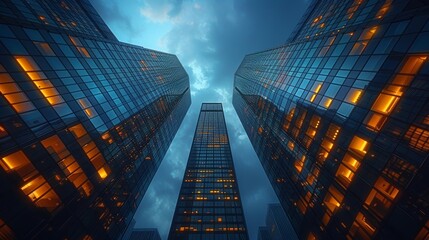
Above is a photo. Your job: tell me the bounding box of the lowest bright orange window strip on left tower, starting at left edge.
[0,151,61,211]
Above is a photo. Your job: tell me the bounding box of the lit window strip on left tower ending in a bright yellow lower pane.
[69,124,110,179]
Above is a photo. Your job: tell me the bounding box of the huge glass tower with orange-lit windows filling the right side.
[233,0,429,239]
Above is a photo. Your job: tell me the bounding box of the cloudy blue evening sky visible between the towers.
[91,0,309,239]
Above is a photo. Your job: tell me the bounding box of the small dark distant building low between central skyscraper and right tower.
[258,203,298,240]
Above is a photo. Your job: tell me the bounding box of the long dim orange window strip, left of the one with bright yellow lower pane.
[41,135,93,196]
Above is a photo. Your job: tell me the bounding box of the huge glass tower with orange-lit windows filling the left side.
[0,0,191,240]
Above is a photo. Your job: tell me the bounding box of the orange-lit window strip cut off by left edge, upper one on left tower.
[0,73,35,113]
